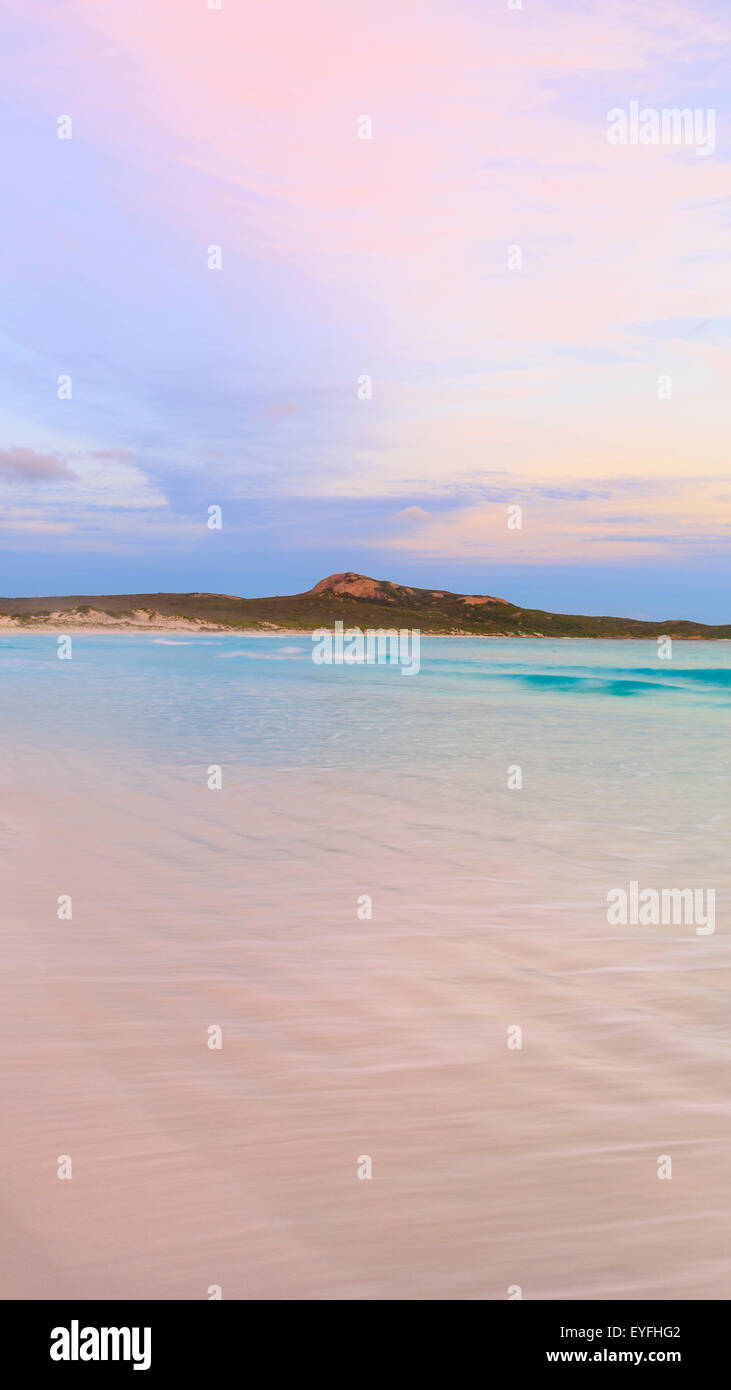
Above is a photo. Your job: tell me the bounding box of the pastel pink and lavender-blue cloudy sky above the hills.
[0,0,731,623]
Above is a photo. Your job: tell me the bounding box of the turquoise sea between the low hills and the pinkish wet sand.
[0,632,731,881]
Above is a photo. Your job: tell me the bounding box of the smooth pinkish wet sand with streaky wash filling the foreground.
[0,751,731,1300]
